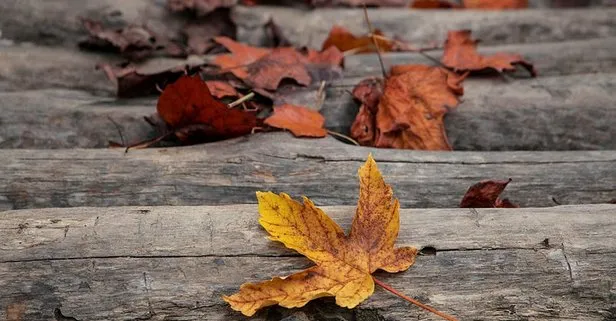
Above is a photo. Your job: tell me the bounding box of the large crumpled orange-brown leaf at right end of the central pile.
[351,65,466,150]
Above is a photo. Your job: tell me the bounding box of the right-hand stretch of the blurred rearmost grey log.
[234,7,616,48]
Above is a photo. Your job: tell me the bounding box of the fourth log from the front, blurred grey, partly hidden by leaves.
[0,37,616,95]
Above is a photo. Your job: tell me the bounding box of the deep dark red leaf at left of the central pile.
[156,76,257,141]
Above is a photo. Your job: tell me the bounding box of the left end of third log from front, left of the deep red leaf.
[0,89,156,148]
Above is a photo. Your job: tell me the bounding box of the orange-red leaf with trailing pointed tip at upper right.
[441,30,537,77]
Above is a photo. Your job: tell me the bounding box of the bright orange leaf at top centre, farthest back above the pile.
[322,25,394,53]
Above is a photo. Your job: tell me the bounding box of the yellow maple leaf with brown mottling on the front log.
[223,155,417,316]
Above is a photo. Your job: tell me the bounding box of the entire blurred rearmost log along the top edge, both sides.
[0,0,616,47]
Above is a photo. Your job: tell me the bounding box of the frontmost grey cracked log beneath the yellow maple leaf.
[0,205,616,321]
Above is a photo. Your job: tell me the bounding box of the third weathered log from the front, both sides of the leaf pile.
[0,74,616,150]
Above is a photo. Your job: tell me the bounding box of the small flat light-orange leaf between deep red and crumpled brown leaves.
[265,104,327,137]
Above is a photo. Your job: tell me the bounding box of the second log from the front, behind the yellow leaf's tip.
[0,133,616,210]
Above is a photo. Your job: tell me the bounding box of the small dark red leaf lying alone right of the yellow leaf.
[460,179,519,208]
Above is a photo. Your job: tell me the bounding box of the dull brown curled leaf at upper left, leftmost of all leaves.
[79,19,163,61]
